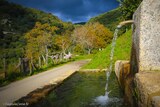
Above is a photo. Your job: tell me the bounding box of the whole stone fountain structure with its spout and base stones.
[115,0,160,107]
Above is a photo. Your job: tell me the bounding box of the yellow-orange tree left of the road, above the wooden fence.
[25,22,57,68]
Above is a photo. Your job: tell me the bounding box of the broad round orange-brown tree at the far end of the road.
[72,22,112,54]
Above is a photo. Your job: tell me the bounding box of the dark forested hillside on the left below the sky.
[0,0,73,55]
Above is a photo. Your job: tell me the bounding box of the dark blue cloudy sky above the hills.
[8,0,119,23]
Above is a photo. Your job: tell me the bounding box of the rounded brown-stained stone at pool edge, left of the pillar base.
[115,60,133,107]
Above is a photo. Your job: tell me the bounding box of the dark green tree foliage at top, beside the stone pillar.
[118,0,142,20]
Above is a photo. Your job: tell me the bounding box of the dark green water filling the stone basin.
[33,72,123,107]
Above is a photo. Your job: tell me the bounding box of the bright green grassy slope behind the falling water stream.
[82,30,131,69]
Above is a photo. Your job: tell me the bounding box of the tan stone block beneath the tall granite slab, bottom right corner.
[134,71,160,107]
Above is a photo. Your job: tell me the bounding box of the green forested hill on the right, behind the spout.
[88,8,122,31]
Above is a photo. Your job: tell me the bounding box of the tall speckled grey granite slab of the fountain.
[131,0,160,72]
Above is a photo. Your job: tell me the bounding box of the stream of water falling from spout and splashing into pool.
[94,27,120,106]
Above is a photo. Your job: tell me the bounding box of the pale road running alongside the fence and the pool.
[0,60,88,107]
